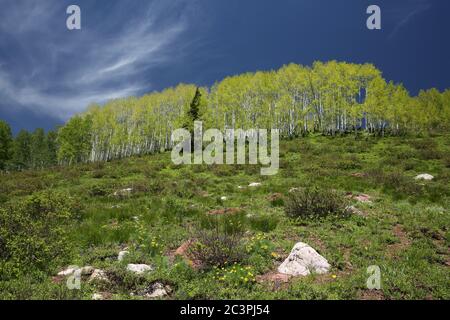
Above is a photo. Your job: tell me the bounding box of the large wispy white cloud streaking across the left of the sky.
[0,0,195,120]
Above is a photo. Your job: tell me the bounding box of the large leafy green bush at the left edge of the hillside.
[0,192,80,279]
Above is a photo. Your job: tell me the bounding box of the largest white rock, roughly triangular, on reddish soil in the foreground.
[278,242,330,276]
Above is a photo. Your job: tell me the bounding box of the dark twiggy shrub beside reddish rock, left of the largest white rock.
[189,225,245,269]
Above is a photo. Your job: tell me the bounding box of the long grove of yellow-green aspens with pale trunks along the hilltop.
[57,61,450,164]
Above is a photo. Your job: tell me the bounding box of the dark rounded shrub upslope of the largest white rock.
[285,188,346,218]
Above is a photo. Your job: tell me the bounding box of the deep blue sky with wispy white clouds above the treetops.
[0,0,450,132]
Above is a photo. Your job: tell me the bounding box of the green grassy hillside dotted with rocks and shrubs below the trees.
[0,135,450,299]
